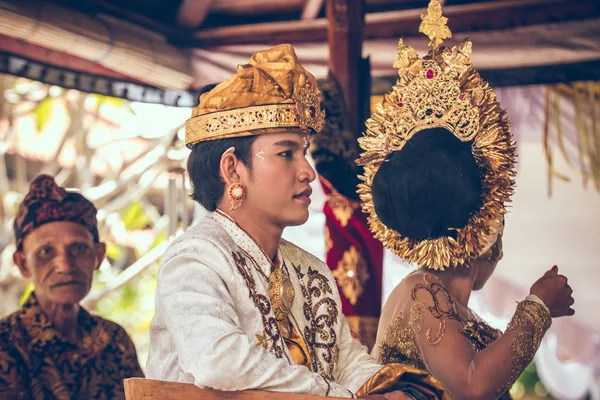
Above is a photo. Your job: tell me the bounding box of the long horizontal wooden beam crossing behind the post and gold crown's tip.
[187,0,600,47]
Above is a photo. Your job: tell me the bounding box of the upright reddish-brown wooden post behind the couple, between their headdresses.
[327,0,371,137]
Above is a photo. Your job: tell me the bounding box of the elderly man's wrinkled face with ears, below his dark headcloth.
[13,222,106,304]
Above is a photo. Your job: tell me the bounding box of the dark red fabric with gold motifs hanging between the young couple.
[320,177,383,318]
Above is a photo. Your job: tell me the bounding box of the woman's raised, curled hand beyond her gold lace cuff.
[529,266,575,318]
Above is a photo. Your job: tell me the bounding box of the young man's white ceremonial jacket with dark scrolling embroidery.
[146,213,382,397]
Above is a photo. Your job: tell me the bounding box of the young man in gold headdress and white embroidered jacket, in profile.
[147,45,443,399]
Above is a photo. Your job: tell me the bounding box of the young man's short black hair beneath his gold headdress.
[187,136,256,211]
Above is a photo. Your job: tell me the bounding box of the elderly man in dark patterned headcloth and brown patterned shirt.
[0,175,143,399]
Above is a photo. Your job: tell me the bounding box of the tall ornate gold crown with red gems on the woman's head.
[357,0,516,270]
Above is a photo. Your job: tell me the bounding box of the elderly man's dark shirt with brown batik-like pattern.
[0,294,144,400]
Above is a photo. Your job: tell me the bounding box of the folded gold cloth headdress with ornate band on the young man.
[185,44,325,148]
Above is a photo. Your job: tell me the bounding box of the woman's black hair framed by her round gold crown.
[372,128,482,240]
